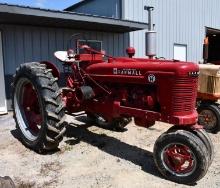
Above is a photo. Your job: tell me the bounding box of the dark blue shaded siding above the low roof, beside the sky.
[68,0,121,19]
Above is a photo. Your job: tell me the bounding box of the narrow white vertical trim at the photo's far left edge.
[0,31,8,114]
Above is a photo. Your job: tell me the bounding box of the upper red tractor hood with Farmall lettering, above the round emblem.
[86,58,199,77]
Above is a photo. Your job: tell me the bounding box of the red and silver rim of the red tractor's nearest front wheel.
[161,144,197,177]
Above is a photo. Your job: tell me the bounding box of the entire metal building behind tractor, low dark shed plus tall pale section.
[0,0,220,113]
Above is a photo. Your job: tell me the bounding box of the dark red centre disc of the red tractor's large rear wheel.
[21,82,43,135]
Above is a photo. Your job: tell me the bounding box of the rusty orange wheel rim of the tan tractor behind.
[199,110,217,129]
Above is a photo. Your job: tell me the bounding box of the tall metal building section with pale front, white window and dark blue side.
[69,0,220,62]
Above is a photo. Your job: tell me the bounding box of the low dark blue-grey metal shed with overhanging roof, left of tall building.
[0,4,146,114]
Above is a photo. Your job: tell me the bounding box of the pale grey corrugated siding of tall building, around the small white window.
[122,0,220,62]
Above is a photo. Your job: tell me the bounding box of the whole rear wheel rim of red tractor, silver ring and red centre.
[14,78,43,141]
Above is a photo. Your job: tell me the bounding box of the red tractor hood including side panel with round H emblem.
[86,58,199,84]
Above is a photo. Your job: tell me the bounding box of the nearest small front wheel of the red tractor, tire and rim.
[154,130,209,184]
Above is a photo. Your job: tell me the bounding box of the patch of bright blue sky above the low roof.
[0,0,80,10]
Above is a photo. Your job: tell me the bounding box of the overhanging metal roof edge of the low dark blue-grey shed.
[0,3,147,33]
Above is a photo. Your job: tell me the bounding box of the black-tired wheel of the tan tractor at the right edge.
[197,103,220,133]
